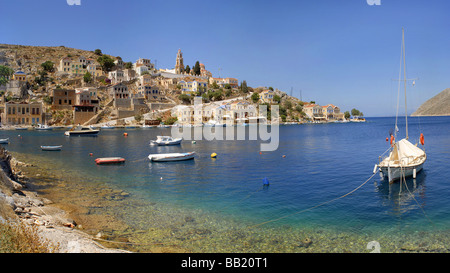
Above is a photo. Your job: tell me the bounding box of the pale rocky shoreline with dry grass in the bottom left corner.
[0,147,128,253]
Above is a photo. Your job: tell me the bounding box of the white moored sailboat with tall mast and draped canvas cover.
[374,28,427,183]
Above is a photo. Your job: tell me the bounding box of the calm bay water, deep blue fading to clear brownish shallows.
[0,117,450,253]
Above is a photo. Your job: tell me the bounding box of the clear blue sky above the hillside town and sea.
[0,0,450,116]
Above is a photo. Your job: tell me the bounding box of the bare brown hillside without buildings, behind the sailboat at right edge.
[412,88,450,116]
